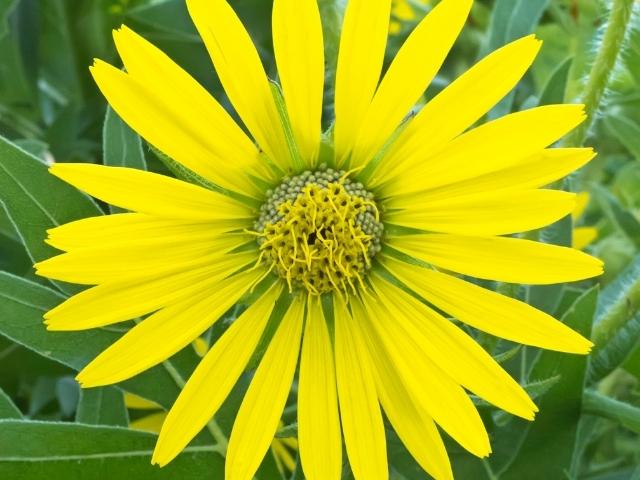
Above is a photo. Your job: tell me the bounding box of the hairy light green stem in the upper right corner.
[565,0,634,147]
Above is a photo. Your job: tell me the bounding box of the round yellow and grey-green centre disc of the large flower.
[255,167,383,295]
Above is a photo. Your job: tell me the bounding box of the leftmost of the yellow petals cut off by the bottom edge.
[225,295,304,480]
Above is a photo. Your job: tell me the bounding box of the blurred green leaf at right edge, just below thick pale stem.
[588,314,640,384]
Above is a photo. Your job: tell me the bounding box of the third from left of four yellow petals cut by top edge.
[334,0,391,165]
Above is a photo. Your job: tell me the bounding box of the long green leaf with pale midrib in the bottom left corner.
[0,420,224,480]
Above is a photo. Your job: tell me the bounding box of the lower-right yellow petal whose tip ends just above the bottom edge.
[353,298,491,457]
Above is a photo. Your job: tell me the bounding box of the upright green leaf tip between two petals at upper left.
[102,107,147,213]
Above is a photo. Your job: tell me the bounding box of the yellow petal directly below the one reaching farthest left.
[44,253,255,330]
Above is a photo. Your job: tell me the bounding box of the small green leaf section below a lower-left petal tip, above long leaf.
[76,387,129,427]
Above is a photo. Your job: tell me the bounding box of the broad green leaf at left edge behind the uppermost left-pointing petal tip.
[0,133,102,292]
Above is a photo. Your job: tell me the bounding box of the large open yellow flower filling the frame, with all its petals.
[37,0,602,480]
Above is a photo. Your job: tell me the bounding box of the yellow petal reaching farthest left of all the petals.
[35,235,249,285]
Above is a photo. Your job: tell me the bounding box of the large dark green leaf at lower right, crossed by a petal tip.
[492,286,598,480]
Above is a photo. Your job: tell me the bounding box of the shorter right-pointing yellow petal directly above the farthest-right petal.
[385,190,575,235]
